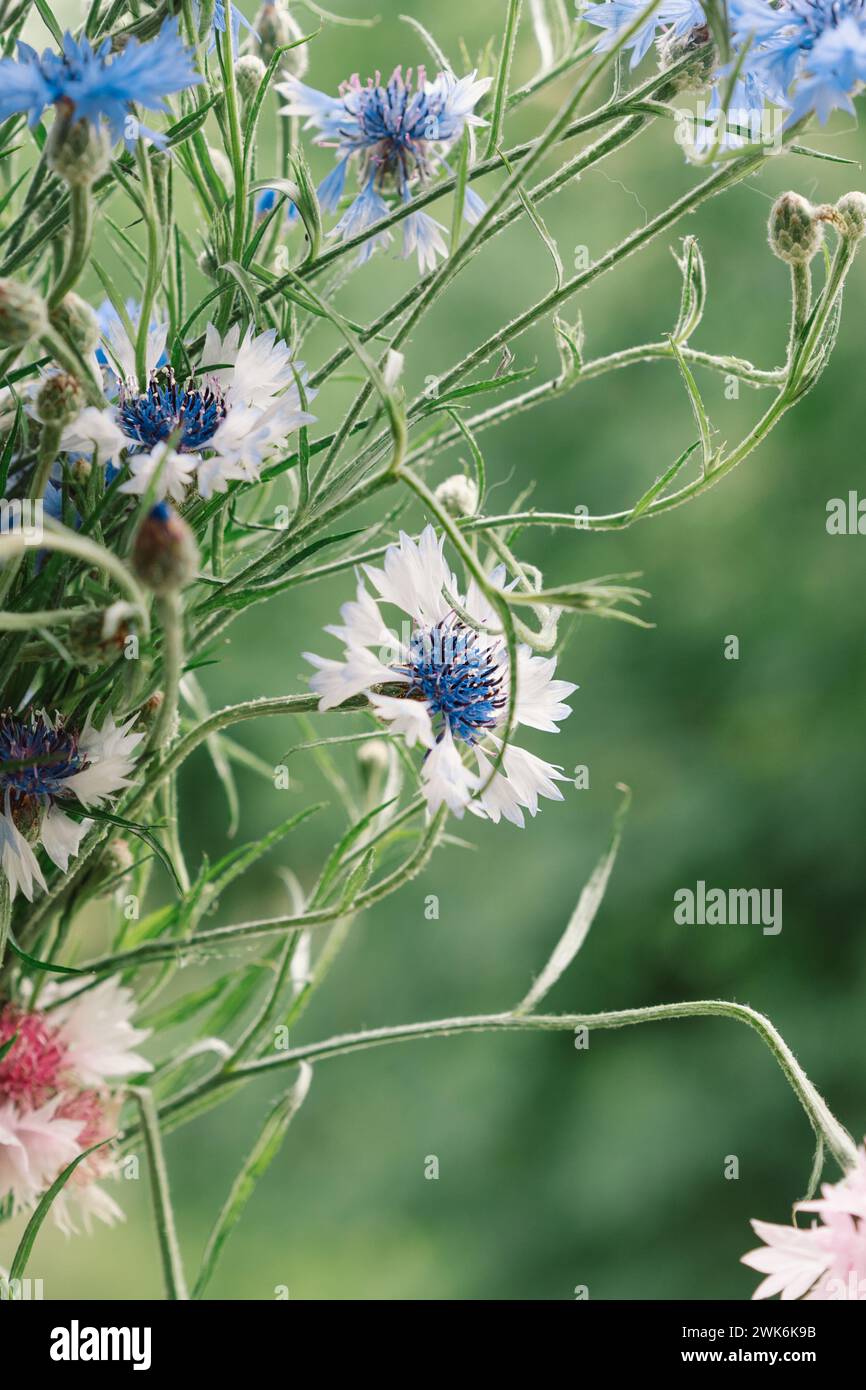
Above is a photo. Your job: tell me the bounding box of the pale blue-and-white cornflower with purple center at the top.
[277,68,491,270]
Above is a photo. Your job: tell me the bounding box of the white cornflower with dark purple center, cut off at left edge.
[0,710,145,901]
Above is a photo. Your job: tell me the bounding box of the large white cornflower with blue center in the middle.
[307,525,577,826]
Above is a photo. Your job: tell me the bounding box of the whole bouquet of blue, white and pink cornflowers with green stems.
[0,0,866,1298]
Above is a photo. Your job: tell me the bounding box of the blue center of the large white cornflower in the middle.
[398,614,506,744]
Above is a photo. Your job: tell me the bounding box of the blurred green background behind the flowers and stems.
[6,0,866,1300]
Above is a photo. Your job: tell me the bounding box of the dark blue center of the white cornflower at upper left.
[118,367,228,453]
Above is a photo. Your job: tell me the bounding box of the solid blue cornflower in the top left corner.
[0,19,203,145]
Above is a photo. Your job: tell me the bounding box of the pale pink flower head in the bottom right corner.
[742,1148,866,1301]
